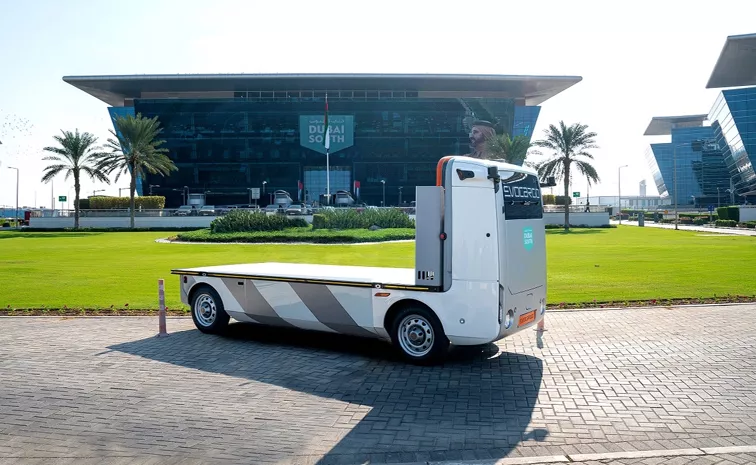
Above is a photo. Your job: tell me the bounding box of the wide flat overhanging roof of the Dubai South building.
[63,74,582,106]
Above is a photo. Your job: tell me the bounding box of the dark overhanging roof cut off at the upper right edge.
[706,34,756,89]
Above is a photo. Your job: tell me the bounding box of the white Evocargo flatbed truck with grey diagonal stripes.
[172,156,546,363]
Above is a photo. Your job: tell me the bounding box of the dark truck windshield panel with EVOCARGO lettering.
[500,171,543,220]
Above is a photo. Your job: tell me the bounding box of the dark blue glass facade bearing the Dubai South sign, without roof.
[133,91,540,207]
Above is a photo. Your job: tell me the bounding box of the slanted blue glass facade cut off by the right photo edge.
[709,87,756,202]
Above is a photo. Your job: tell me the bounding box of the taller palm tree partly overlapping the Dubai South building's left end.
[94,114,178,228]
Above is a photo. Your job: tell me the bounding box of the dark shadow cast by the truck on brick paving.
[109,323,548,465]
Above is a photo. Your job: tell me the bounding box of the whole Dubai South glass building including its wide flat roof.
[63,75,581,207]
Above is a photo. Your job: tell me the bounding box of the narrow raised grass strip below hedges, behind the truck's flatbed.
[178,227,415,244]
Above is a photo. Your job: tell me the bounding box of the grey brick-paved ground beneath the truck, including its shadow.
[0,305,756,465]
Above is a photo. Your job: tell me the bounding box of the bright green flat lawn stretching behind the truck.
[0,227,756,308]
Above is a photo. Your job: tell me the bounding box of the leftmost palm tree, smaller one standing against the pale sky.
[42,129,110,229]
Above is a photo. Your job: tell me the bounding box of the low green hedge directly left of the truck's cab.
[312,208,415,229]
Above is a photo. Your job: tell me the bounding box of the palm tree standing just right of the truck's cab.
[533,121,599,231]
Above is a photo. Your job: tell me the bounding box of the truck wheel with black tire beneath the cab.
[391,306,449,365]
